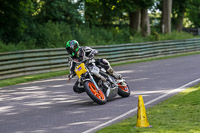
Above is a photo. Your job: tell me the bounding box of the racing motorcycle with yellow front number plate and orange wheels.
[72,58,130,104]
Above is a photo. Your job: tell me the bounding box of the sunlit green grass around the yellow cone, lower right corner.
[97,84,200,133]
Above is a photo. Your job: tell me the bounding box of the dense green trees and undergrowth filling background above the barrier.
[0,0,200,51]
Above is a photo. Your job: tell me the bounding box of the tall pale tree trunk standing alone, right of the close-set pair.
[161,0,172,34]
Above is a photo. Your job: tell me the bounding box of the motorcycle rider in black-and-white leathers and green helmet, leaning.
[66,40,121,93]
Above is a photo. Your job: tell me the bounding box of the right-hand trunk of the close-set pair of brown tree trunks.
[141,9,150,36]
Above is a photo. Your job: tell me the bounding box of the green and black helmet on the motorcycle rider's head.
[66,40,79,56]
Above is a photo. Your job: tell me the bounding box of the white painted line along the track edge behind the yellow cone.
[83,78,200,133]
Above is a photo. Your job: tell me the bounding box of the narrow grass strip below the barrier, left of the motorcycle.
[0,70,69,87]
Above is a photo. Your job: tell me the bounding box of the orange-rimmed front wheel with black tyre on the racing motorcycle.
[84,81,107,104]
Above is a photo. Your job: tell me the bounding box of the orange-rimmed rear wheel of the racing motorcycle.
[118,82,130,97]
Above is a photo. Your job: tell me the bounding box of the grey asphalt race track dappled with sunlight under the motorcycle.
[0,55,200,133]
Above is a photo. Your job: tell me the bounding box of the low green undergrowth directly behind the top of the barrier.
[0,21,196,52]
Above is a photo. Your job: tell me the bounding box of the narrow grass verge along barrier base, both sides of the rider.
[0,52,200,87]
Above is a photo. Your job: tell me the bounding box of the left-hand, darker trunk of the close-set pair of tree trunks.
[129,10,141,34]
